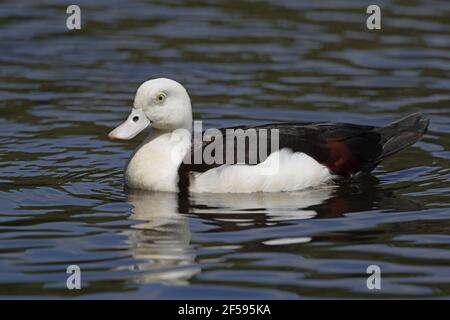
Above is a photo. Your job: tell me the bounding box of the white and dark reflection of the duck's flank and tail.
[184,175,421,224]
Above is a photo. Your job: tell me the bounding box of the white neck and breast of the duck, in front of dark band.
[125,129,191,192]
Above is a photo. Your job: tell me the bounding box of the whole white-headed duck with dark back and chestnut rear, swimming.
[108,78,429,194]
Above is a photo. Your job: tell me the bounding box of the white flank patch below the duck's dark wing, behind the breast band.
[190,149,332,193]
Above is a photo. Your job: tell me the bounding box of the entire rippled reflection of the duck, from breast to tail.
[121,178,420,284]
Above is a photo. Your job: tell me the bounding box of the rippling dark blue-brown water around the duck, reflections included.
[0,0,450,299]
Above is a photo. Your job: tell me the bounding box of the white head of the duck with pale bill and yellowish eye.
[108,78,192,140]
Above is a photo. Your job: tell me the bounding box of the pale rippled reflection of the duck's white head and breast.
[126,191,201,284]
